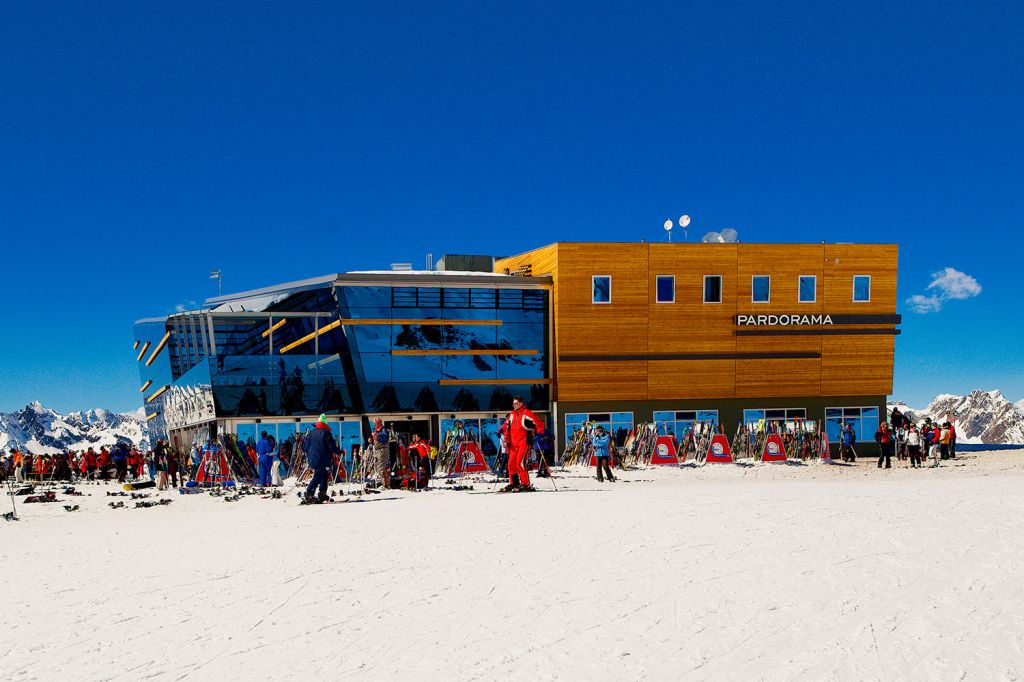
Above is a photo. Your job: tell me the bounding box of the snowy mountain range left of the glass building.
[0,400,150,455]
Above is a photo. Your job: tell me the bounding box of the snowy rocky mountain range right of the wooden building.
[888,390,1024,445]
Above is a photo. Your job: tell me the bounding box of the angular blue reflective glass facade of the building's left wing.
[135,283,550,438]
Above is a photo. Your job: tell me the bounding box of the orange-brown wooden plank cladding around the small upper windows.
[495,243,899,402]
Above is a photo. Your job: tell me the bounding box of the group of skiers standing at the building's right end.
[840,408,956,469]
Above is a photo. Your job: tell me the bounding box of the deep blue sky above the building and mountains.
[0,0,1024,411]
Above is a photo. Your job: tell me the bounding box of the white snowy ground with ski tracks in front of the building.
[0,452,1024,680]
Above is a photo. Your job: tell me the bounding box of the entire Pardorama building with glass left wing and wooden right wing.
[135,243,900,455]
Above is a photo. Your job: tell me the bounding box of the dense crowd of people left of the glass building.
[0,440,183,485]
